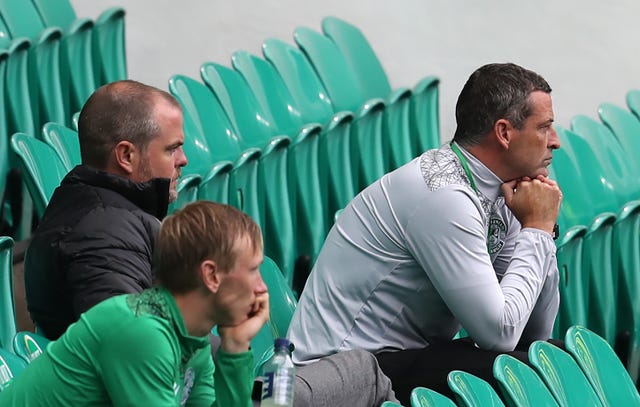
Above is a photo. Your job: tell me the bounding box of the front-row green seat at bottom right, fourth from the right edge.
[447,370,504,407]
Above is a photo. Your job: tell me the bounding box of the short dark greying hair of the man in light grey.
[453,63,551,145]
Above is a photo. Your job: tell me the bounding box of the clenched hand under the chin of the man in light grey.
[501,175,562,234]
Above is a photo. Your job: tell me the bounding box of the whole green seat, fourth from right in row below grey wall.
[231,51,327,262]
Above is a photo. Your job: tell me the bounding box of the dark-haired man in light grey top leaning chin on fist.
[289,64,562,404]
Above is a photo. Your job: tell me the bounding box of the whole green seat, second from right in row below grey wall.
[293,27,384,190]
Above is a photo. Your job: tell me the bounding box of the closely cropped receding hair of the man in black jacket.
[78,80,182,169]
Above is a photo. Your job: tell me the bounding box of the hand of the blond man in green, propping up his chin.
[218,292,269,353]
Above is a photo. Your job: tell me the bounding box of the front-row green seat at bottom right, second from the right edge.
[529,341,602,407]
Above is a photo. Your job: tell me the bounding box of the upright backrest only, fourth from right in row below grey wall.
[231,51,304,137]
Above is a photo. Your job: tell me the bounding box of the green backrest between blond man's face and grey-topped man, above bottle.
[260,256,297,338]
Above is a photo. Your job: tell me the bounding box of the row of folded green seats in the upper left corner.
[0,0,126,239]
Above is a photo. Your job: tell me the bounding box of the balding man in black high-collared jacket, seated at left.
[25,80,187,339]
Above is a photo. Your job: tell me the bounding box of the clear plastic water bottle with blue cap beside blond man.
[260,338,296,407]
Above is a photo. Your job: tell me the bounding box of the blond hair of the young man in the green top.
[154,201,262,294]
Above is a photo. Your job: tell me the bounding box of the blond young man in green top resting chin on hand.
[0,201,269,407]
